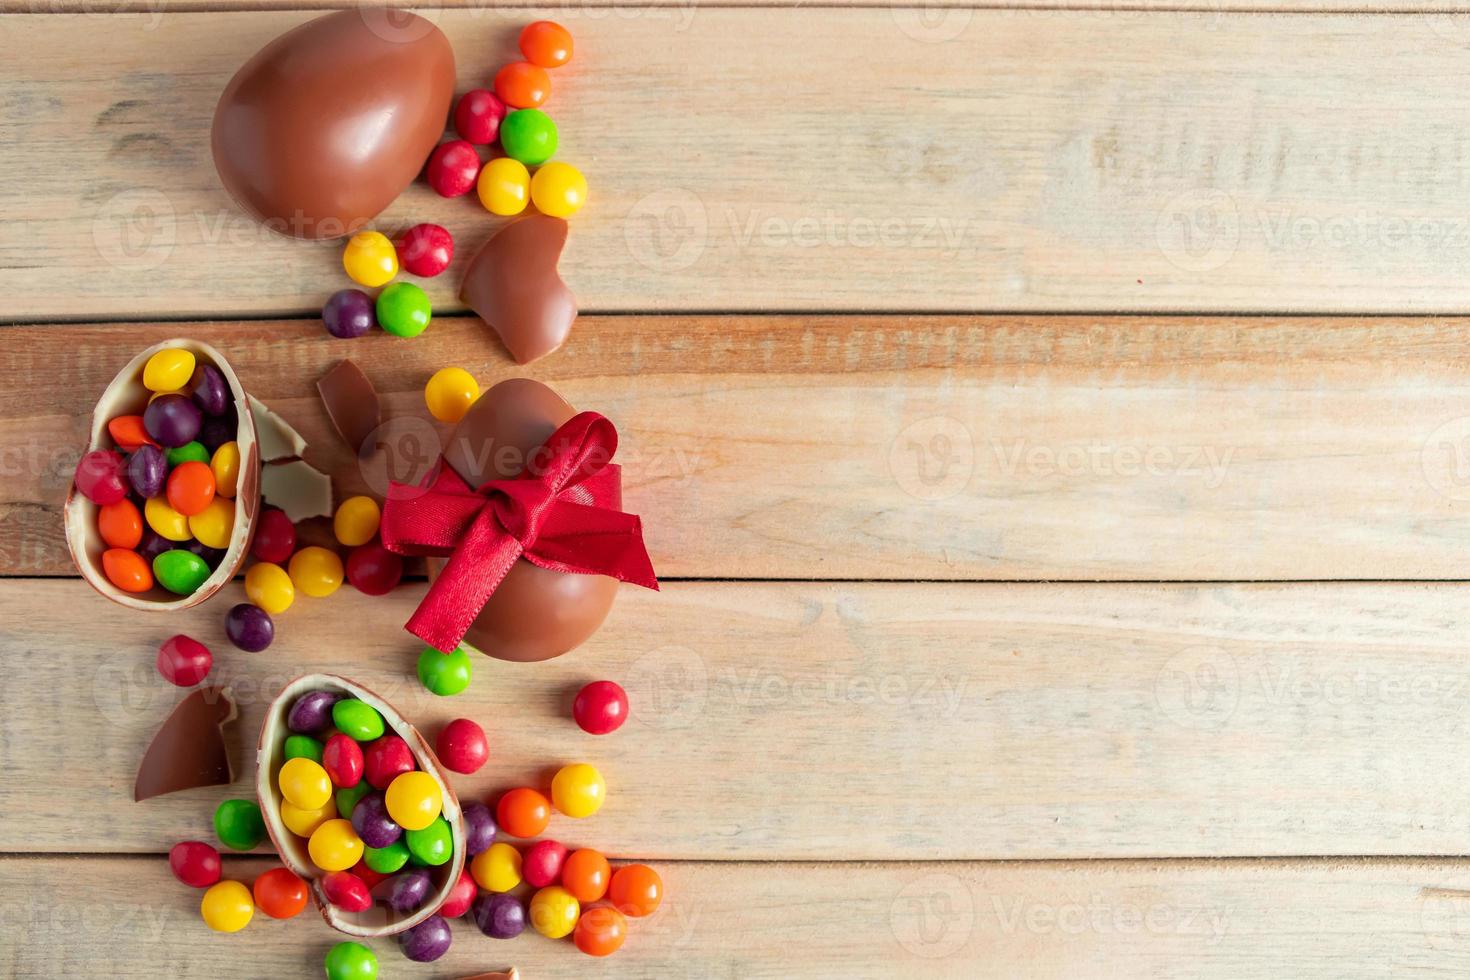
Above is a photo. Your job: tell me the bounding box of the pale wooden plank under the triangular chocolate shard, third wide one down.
[0,580,1470,860]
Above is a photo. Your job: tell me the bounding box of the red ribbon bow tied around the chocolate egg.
[381,411,659,652]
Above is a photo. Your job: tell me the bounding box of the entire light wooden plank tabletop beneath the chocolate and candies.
[0,0,1470,980]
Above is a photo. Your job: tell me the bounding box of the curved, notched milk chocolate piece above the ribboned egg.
[460,215,576,364]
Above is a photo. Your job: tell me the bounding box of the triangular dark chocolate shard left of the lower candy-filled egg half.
[132,688,235,802]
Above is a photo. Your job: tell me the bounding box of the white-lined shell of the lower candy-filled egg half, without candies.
[256,674,465,939]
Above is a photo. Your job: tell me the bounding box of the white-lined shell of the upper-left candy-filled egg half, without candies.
[63,338,260,610]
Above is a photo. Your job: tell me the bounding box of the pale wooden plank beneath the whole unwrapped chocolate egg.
[14,4,1470,320]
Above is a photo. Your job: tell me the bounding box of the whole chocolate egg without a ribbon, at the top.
[210,7,454,238]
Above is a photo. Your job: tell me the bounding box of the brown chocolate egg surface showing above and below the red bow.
[428,378,617,661]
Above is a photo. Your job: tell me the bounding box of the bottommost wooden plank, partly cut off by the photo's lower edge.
[0,857,1470,980]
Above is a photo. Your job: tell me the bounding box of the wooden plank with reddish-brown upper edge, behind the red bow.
[0,316,1470,580]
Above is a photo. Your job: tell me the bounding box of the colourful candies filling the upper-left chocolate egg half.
[75,348,241,595]
